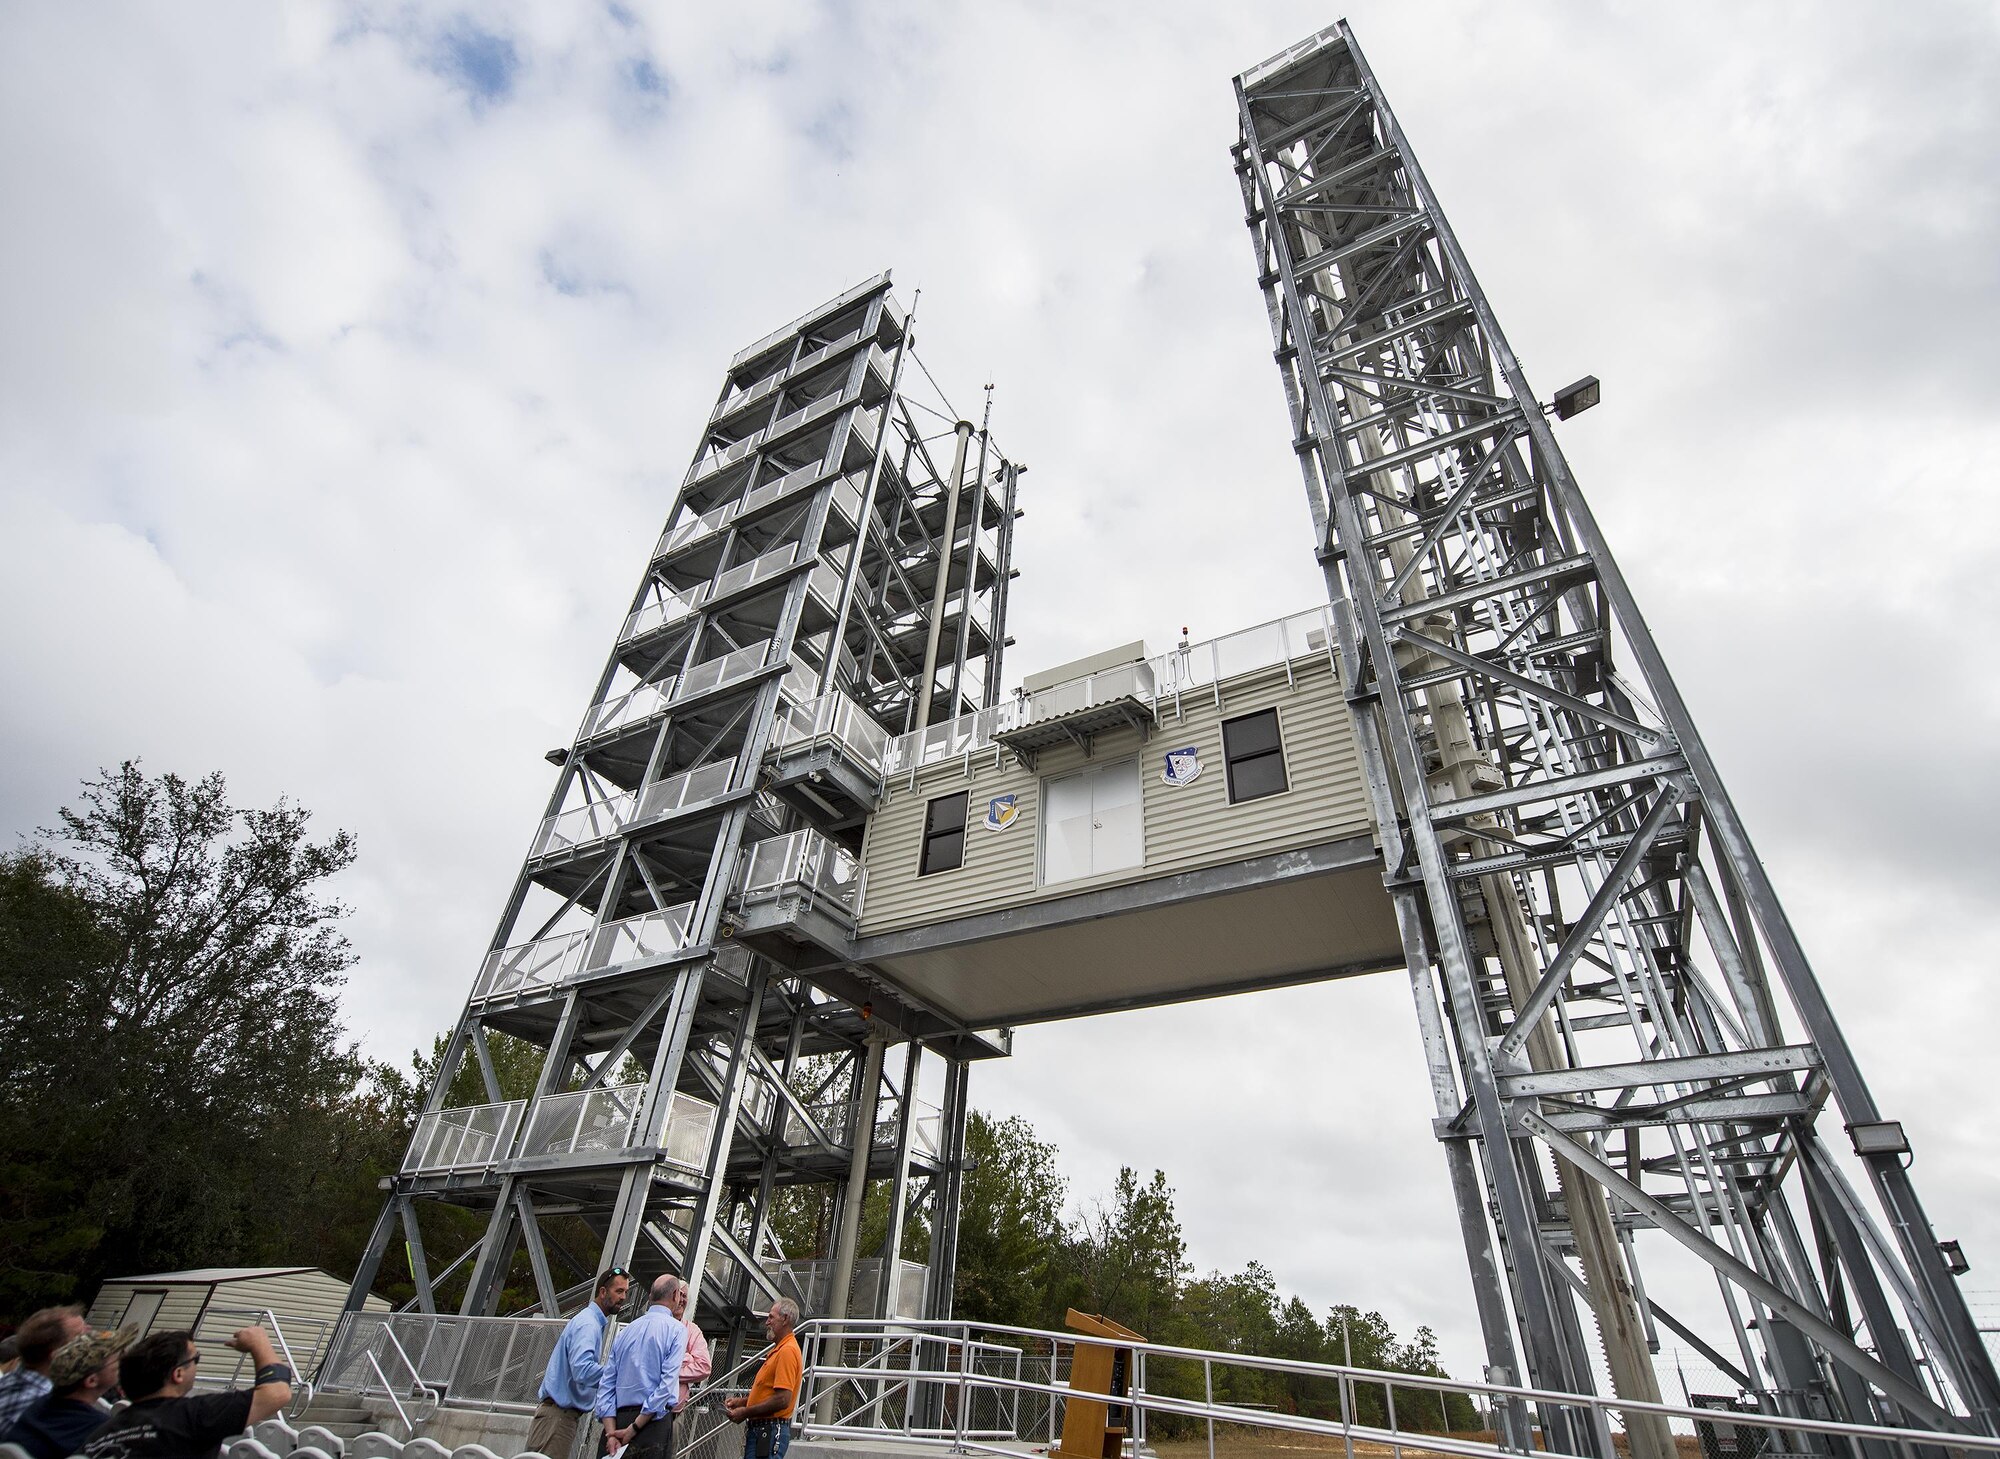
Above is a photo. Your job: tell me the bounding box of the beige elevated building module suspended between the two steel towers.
[738,610,1402,1025]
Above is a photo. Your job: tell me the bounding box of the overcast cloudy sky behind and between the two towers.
[0,0,2000,1373]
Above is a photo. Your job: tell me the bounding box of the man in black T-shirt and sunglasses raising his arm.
[82,1327,292,1459]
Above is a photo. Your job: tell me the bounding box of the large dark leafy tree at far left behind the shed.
[0,761,378,1309]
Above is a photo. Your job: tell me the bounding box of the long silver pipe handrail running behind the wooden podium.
[798,1317,2000,1459]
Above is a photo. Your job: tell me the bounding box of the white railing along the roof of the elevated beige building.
[882,608,1334,775]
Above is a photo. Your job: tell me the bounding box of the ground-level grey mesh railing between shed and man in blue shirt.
[320,1311,564,1425]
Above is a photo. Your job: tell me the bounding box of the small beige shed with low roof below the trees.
[90,1267,388,1385]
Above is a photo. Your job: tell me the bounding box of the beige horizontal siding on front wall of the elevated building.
[858,660,1370,937]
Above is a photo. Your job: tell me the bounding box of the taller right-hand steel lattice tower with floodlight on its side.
[1234,24,2000,1459]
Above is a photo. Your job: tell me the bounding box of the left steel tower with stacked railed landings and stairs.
[350,274,1024,1357]
